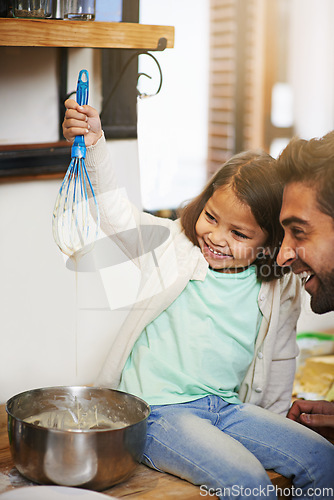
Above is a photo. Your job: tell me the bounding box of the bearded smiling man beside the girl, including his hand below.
[277,132,334,439]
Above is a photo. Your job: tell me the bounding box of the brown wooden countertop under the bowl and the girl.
[0,405,291,500]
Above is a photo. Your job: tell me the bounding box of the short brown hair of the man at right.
[277,131,334,219]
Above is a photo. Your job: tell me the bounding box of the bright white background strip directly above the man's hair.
[287,0,334,139]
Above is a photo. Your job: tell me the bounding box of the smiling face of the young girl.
[196,186,268,273]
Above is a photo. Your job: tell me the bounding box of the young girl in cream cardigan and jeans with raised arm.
[63,100,334,498]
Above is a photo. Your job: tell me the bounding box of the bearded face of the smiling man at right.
[277,182,334,314]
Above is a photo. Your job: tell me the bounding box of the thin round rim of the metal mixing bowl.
[5,385,151,434]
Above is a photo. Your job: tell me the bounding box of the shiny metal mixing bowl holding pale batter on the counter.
[6,387,150,491]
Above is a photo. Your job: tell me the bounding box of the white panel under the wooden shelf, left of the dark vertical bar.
[0,47,58,144]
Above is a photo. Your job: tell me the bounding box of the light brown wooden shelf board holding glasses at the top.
[0,18,174,50]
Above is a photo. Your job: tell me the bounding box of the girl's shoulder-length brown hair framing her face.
[181,151,289,281]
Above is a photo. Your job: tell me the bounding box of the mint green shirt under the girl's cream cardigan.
[119,266,262,405]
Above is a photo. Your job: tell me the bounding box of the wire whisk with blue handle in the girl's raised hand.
[52,69,100,256]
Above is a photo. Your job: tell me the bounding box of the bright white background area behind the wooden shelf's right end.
[138,0,210,210]
